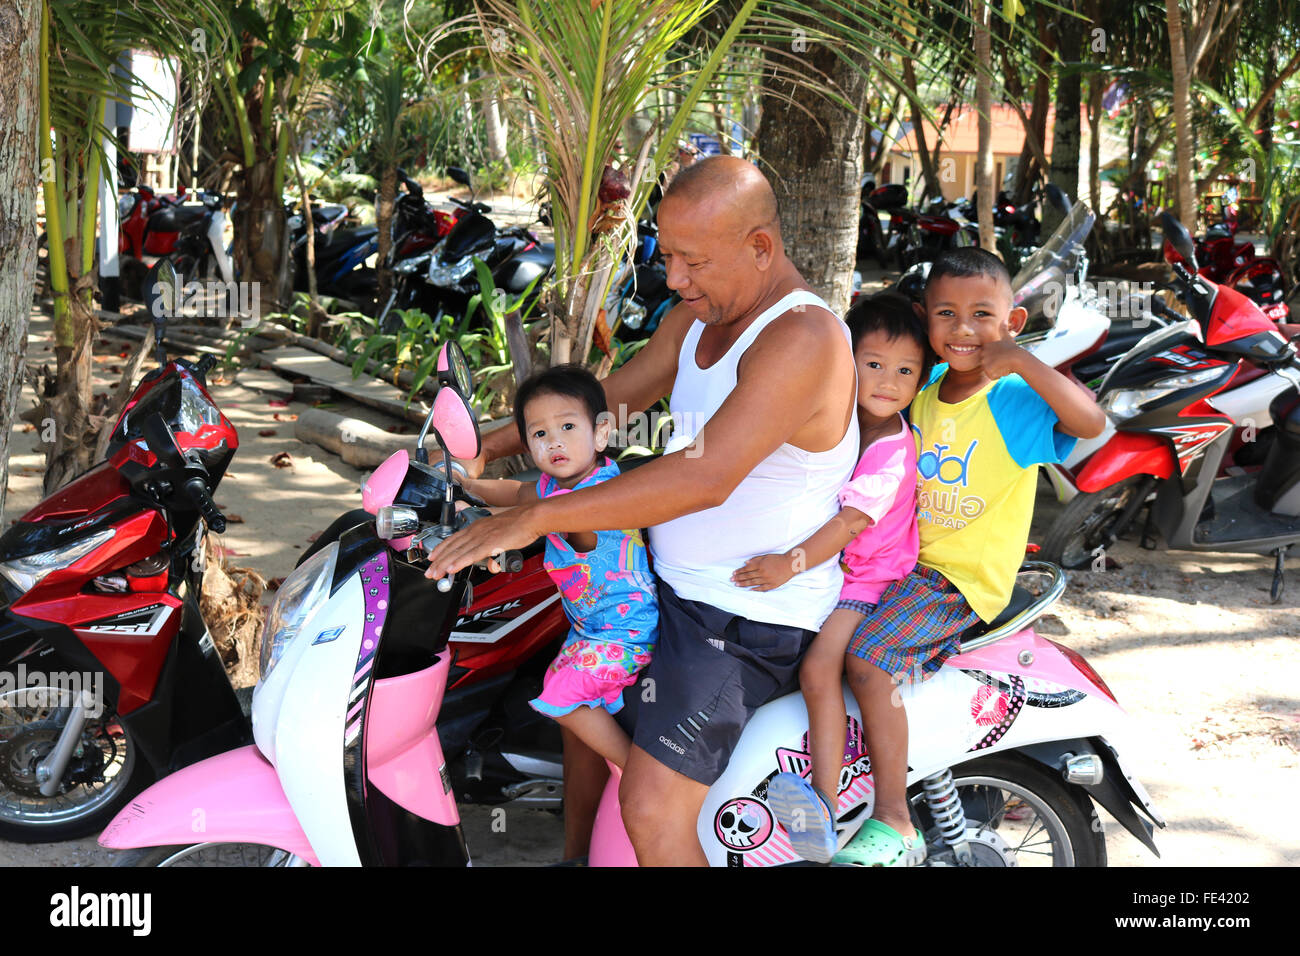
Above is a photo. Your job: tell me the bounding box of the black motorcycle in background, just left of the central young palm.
[378,166,555,333]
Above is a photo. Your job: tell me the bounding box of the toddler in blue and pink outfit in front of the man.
[463,365,659,769]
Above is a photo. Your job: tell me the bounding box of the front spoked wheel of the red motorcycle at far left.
[0,684,153,843]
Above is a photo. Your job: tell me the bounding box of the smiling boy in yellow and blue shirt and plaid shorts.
[785,248,1106,866]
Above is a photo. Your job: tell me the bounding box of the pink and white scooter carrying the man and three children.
[100,345,1164,866]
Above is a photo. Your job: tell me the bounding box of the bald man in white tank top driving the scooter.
[429,156,858,866]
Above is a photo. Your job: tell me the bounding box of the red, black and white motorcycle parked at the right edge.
[1043,213,1300,602]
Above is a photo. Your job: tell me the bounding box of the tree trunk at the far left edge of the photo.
[0,0,40,520]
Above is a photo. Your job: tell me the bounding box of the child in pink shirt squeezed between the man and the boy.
[732,293,932,862]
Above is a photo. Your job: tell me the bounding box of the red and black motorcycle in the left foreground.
[0,260,250,843]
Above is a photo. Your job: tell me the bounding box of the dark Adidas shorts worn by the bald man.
[616,579,816,784]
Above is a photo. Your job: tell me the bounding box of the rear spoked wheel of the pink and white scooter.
[909,754,1106,866]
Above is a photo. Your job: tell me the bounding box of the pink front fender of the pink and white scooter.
[99,744,320,866]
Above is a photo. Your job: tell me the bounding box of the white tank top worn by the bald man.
[650,290,858,631]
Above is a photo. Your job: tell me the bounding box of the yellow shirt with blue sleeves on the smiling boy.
[910,364,1076,622]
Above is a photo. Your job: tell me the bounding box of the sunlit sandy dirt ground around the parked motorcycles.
[0,291,1300,866]
